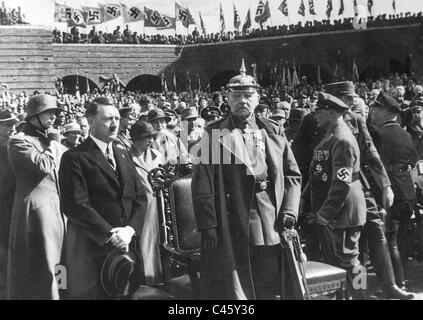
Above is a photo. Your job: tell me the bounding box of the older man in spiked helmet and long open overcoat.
[192,63,301,299]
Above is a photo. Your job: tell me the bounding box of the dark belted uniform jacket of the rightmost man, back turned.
[374,121,418,201]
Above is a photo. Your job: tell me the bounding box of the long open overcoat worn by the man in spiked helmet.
[191,116,301,300]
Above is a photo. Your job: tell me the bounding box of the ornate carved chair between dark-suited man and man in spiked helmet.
[148,164,201,299]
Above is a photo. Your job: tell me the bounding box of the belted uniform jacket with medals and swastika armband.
[305,122,366,228]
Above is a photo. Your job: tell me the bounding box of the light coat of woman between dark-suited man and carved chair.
[131,148,163,285]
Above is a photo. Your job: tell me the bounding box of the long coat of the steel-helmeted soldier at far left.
[7,124,66,300]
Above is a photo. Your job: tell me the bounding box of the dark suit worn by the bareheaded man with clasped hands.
[59,138,147,299]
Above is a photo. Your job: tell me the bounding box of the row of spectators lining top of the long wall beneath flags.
[53,12,423,45]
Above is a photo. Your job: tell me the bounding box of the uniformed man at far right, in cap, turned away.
[370,91,418,296]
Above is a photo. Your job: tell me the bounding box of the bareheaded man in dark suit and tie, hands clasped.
[59,97,147,299]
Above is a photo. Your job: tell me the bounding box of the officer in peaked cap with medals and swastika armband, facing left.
[304,93,366,298]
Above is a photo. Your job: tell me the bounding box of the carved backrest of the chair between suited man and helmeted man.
[148,165,201,256]
